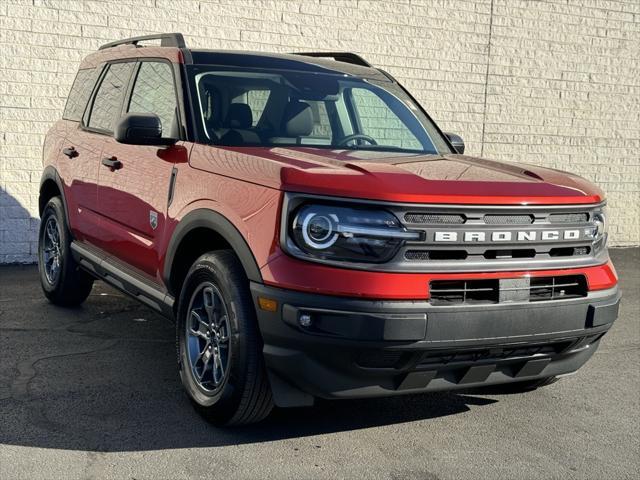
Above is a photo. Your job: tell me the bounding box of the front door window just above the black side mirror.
[127,62,177,137]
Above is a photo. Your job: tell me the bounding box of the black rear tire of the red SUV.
[38,197,93,307]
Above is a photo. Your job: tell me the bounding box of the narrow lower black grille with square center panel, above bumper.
[430,275,587,305]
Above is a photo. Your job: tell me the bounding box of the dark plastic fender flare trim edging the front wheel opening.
[162,208,262,290]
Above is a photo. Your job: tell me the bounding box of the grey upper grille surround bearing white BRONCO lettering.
[394,204,608,272]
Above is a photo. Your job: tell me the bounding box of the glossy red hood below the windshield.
[192,147,604,205]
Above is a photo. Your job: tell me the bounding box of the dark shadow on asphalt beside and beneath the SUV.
[0,267,494,452]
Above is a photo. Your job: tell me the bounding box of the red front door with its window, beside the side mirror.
[97,60,187,279]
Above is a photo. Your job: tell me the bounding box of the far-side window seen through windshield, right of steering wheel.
[351,88,422,150]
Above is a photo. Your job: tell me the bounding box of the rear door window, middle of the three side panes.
[87,62,134,132]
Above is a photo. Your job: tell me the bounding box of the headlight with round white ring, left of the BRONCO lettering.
[290,204,421,263]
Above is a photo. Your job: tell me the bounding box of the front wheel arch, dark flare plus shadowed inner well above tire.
[162,208,262,296]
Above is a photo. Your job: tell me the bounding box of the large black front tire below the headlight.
[176,250,273,426]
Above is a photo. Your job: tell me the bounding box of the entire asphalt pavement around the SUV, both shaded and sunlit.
[0,249,640,480]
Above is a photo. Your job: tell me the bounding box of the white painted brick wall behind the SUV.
[0,0,640,263]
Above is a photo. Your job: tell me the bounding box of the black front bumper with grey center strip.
[251,283,620,406]
